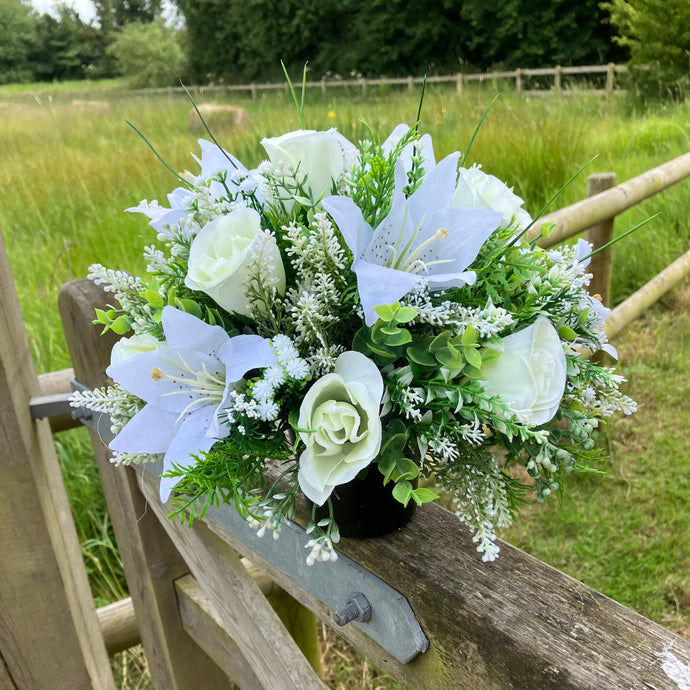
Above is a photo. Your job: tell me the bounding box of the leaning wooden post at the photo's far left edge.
[0,236,115,690]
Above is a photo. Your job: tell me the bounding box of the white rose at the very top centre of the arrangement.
[261,129,357,201]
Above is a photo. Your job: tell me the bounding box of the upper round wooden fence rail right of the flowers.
[527,153,690,247]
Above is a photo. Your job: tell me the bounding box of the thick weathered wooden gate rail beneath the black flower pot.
[189,480,690,690]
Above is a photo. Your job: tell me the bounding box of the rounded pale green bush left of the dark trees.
[107,22,185,88]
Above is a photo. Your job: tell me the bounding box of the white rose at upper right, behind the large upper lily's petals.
[450,164,532,230]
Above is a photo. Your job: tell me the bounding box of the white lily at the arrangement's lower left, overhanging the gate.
[106,306,276,502]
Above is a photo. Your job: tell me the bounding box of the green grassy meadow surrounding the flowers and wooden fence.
[0,86,690,687]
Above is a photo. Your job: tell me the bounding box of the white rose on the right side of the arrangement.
[483,317,566,426]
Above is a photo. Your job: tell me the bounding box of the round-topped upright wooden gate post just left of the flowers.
[58,280,231,690]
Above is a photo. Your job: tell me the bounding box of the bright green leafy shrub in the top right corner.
[601,0,690,103]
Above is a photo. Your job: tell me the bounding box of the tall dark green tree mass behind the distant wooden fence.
[178,0,624,84]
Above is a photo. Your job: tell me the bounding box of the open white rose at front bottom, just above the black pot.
[298,352,383,505]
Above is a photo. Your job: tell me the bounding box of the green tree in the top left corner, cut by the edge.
[0,0,36,84]
